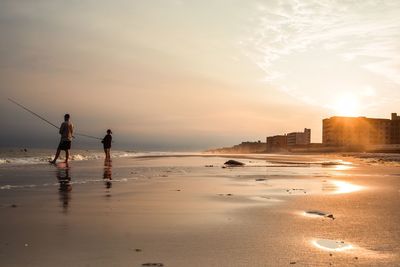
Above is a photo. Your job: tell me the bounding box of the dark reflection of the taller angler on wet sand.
[57,163,72,213]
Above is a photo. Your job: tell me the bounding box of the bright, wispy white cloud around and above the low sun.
[240,0,400,113]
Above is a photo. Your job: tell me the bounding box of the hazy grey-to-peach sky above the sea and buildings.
[0,0,400,151]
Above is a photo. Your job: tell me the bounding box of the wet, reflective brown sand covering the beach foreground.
[0,155,400,266]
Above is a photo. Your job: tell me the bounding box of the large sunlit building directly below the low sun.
[322,113,400,146]
